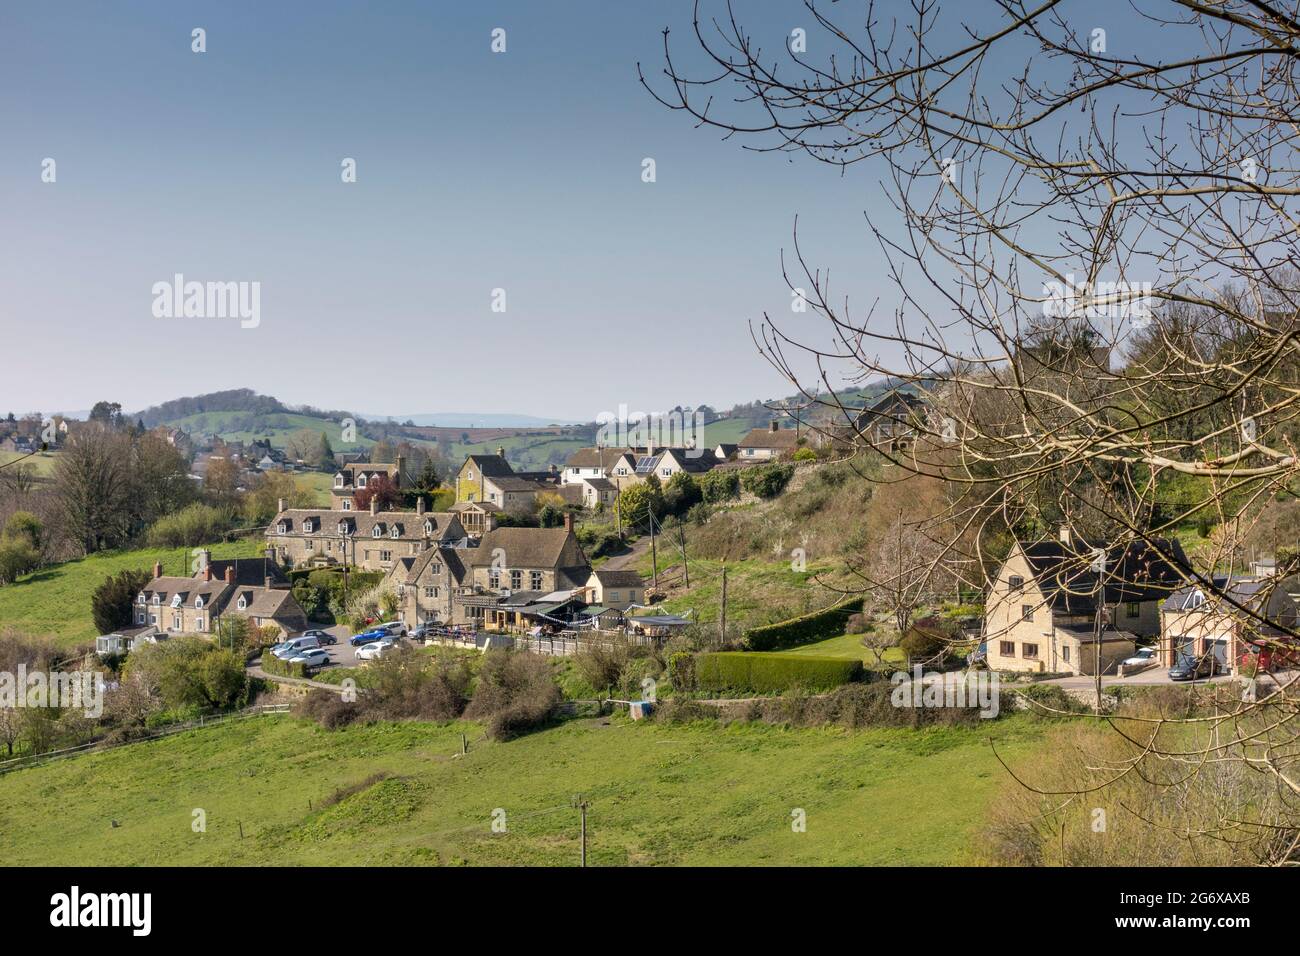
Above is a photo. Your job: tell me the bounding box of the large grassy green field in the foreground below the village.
[0,715,1040,866]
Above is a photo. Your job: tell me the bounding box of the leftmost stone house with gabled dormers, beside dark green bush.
[134,551,307,635]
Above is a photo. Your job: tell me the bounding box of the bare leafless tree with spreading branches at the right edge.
[642,0,1300,862]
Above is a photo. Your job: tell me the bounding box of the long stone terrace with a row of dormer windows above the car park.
[267,498,467,571]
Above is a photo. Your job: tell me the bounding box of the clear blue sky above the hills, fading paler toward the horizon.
[0,0,1175,420]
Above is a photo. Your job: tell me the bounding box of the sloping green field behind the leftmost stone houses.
[0,538,265,648]
